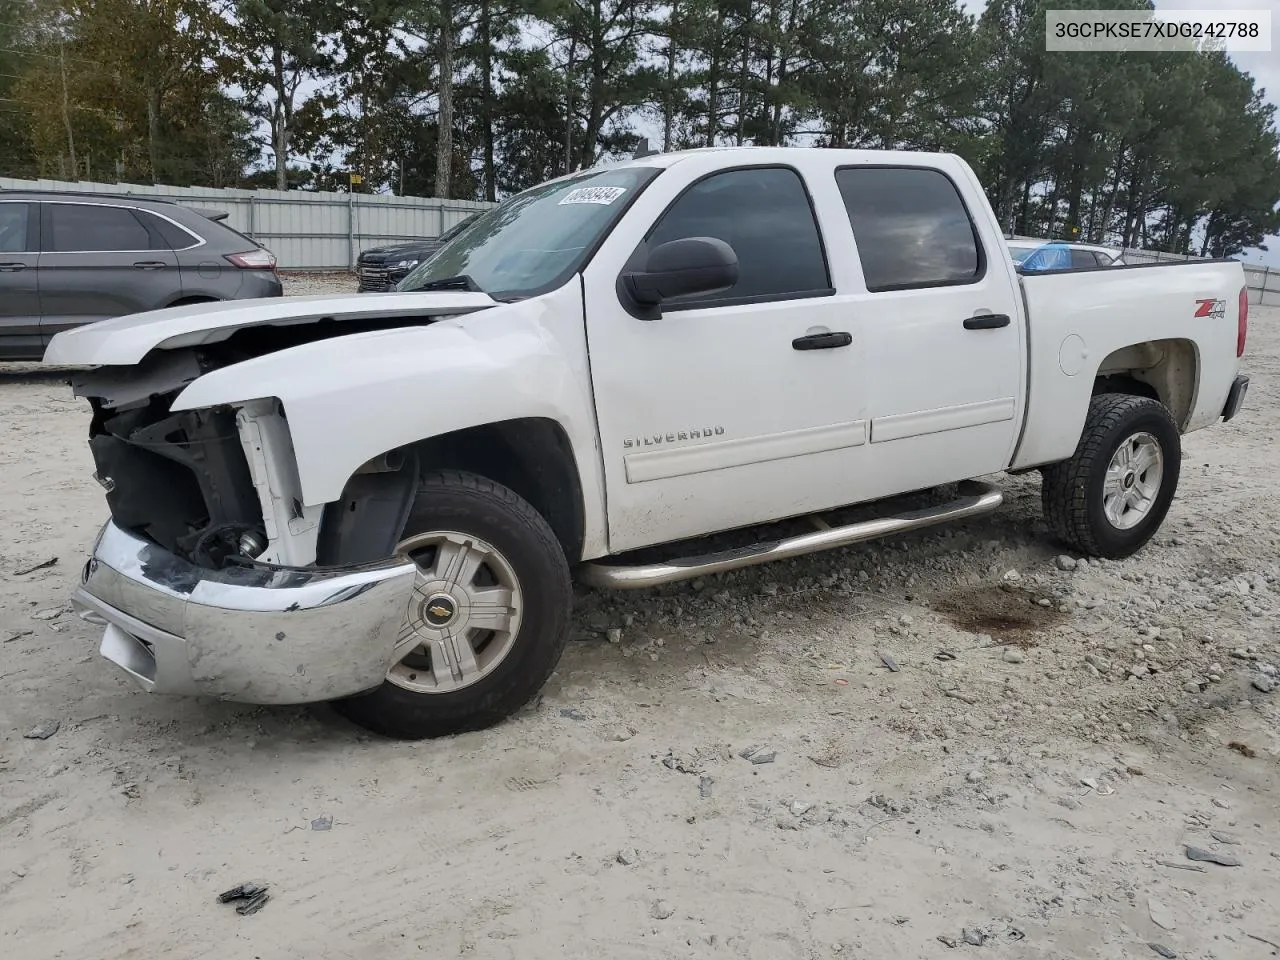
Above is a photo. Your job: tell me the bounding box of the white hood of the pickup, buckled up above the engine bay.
[44,291,498,366]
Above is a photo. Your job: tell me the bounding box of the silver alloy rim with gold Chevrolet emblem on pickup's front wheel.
[387,530,524,694]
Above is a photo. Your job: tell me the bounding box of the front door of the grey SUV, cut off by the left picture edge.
[0,200,44,360]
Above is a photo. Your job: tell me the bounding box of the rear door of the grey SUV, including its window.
[40,200,182,343]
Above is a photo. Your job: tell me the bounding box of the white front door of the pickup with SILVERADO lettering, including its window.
[584,161,867,553]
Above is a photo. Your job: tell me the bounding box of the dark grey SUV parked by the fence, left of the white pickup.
[0,191,283,360]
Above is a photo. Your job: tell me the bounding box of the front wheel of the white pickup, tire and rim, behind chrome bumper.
[334,471,573,740]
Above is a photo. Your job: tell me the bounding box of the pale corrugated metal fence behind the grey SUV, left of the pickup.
[0,177,493,270]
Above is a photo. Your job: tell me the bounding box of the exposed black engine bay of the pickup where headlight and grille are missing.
[72,316,440,570]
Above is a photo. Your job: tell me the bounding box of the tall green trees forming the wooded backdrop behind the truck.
[0,0,1280,255]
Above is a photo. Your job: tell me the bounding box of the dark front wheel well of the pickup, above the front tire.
[413,417,585,563]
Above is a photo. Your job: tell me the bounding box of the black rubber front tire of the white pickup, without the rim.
[334,471,573,740]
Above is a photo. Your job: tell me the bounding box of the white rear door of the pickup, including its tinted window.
[836,159,1025,497]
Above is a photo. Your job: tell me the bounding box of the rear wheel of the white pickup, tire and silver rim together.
[1041,393,1181,559]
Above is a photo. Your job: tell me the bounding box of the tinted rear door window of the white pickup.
[836,166,986,293]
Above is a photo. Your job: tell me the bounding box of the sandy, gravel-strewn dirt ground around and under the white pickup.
[0,278,1280,960]
